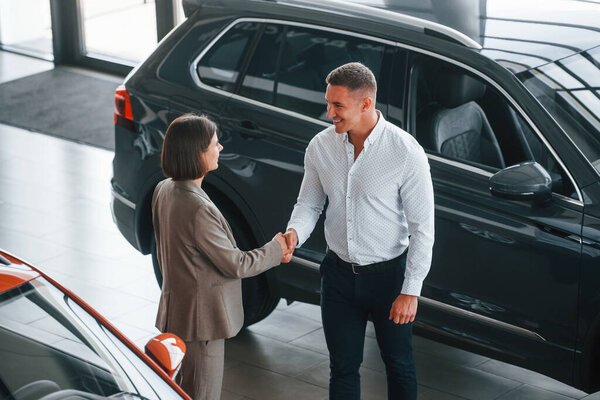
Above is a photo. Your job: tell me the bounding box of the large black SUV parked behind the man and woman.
[112,0,600,391]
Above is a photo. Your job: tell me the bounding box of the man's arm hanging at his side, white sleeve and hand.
[389,145,435,324]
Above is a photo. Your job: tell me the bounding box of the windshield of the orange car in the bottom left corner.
[0,277,181,399]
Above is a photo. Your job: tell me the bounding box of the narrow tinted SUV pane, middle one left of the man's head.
[240,24,284,104]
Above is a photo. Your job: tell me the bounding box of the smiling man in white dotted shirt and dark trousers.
[285,63,434,400]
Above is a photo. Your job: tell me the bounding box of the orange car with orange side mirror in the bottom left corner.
[0,250,189,400]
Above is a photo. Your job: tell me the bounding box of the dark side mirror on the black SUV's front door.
[490,161,552,205]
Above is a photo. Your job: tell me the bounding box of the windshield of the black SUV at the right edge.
[516,46,600,173]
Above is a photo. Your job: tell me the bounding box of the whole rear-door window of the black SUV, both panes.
[232,23,402,122]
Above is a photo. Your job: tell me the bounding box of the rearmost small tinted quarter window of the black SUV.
[198,22,259,92]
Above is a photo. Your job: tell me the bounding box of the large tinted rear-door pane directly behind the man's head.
[276,26,391,120]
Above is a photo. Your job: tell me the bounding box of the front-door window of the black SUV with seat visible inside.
[409,55,577,198]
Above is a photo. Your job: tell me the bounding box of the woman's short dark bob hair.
[160,114,217,181]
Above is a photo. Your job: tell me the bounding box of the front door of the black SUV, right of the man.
[407,51,583,379]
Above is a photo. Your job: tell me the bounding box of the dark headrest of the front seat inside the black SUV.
[434,69,486,108]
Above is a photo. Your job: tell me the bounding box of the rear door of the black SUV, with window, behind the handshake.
[220,22,392,303]
